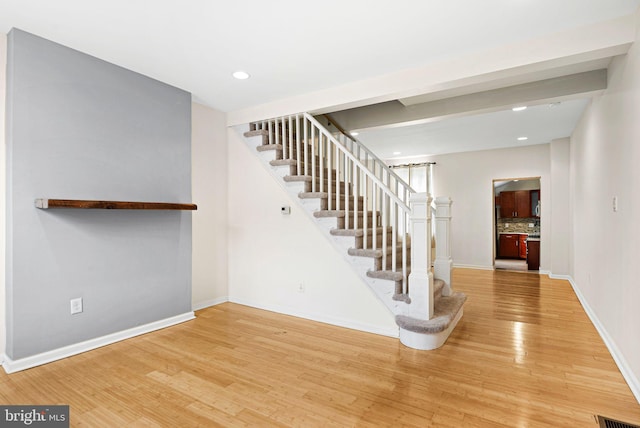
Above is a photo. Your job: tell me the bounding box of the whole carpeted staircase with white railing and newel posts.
[244,113,466,349]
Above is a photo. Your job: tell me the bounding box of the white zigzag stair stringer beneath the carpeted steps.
[240,128,408,316]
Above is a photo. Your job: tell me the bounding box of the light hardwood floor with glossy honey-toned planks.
[0,269,640,428]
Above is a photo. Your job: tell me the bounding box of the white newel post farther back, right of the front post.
[433,196,453,296]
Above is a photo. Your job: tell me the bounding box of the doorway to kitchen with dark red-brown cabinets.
[493,177,540,271]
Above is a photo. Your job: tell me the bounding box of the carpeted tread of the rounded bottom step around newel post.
[396,292,467,334]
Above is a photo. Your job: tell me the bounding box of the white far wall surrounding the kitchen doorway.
[418,144,551,270]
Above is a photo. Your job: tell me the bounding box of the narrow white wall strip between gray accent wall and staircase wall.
[191,103,228,309]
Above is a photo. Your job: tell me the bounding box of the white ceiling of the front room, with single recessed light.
[0,0,640,111]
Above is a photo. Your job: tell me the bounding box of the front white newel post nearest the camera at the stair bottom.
[407,193,434,320]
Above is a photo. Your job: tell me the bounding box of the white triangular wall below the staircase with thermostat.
[228,128,398,335]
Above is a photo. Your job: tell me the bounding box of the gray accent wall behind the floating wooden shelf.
[6,29,193,360]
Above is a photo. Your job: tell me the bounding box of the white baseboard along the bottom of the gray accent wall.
[2,312,195,374]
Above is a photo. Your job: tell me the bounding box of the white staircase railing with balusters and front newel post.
[250,113,450,319]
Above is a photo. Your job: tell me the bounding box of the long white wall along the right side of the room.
[571,8,640,400]
